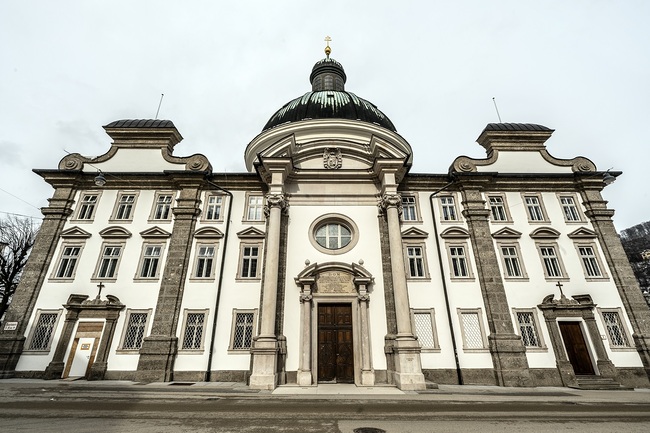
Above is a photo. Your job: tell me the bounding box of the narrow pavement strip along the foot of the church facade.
[0,379,650,404]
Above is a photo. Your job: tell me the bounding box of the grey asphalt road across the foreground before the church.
[0,381,650,433]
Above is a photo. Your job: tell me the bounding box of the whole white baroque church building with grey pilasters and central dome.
[0,51,650,390]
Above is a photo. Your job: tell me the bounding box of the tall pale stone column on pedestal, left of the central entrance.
[250,194,286,389]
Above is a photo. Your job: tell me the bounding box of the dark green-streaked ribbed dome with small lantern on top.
[262,51,396,132]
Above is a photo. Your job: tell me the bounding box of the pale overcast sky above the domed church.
[0,0,650,230]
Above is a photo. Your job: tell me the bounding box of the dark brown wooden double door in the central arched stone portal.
[318,304,354,383]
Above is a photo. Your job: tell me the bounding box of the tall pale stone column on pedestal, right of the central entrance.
[381,193,426,390]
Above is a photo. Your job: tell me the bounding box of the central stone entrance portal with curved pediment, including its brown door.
[295,262,375,386]
